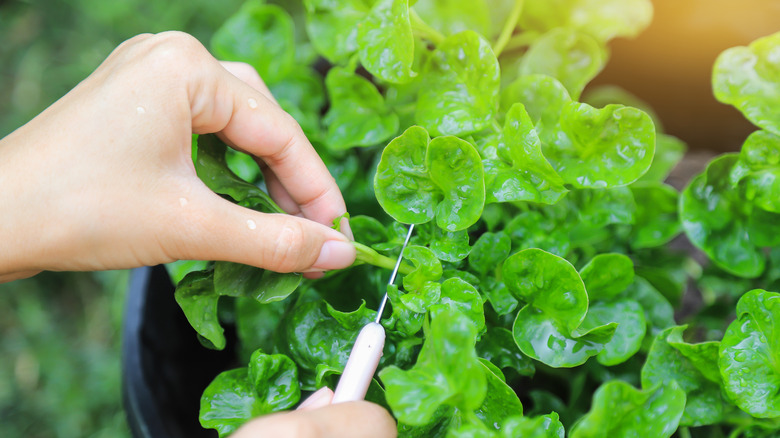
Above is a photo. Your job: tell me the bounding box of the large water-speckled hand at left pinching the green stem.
[0,32,355,281]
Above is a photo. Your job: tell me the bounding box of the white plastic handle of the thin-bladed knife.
[331,322,385,403]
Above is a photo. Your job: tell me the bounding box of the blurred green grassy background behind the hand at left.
[0,0,242,438]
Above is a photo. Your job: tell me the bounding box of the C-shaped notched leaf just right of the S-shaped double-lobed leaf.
[577,299,647,366]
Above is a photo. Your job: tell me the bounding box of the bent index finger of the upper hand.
[189,53,346,225]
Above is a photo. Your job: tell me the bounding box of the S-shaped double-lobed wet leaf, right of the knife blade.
[503,248,616,367]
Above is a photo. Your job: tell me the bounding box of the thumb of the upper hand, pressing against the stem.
[173,192,355,272]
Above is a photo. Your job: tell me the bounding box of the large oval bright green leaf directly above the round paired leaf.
[415,30,499,135]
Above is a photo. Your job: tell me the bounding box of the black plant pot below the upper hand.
[122,266,235,438]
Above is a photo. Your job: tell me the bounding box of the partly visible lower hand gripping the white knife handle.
[230,388,397,438]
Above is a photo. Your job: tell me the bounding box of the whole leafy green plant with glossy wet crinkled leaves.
[170,0,780,438]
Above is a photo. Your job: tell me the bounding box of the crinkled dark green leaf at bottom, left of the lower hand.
[200,350,301,438]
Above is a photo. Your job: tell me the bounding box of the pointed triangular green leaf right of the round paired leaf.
[483,104,567,204]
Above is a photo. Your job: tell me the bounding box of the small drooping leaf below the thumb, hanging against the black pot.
[174,269,226,350]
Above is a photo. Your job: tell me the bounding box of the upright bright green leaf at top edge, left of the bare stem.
[357,0,415,83]
